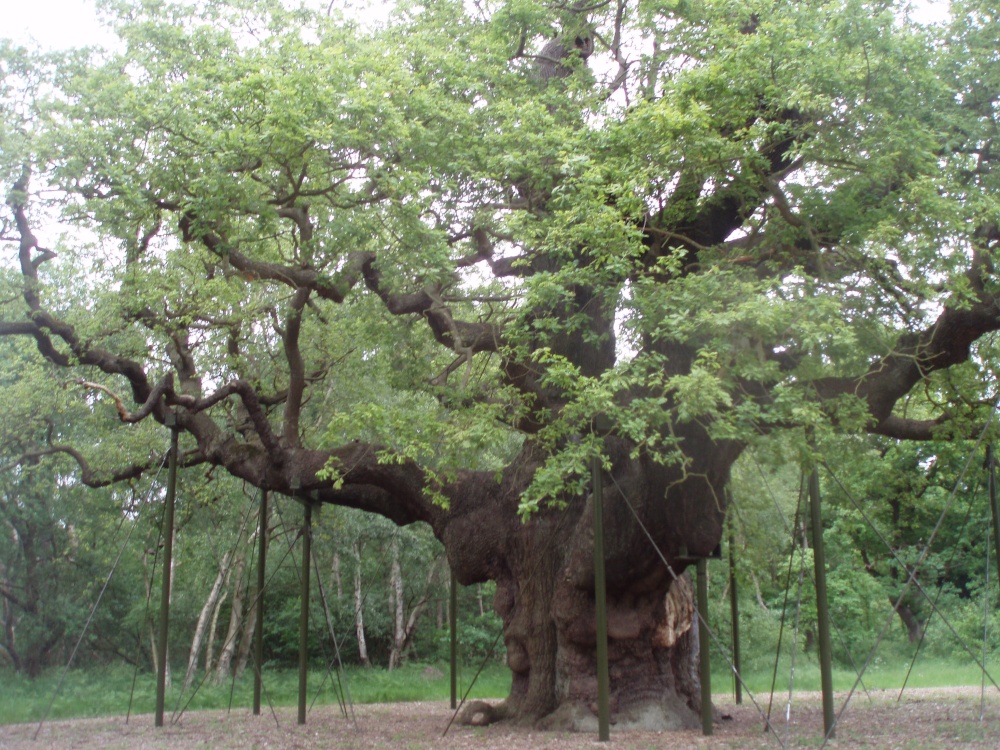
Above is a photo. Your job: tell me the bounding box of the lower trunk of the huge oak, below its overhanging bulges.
[496,522,699,731]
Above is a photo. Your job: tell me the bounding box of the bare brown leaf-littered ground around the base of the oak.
[0,688,1000,750]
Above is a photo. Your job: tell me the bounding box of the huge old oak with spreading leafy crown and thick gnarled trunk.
[0,0,1000,727]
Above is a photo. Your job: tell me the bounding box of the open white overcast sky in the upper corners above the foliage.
[0,0,948,49]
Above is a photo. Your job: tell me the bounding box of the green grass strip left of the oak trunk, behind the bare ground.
[0,664,510,724]
